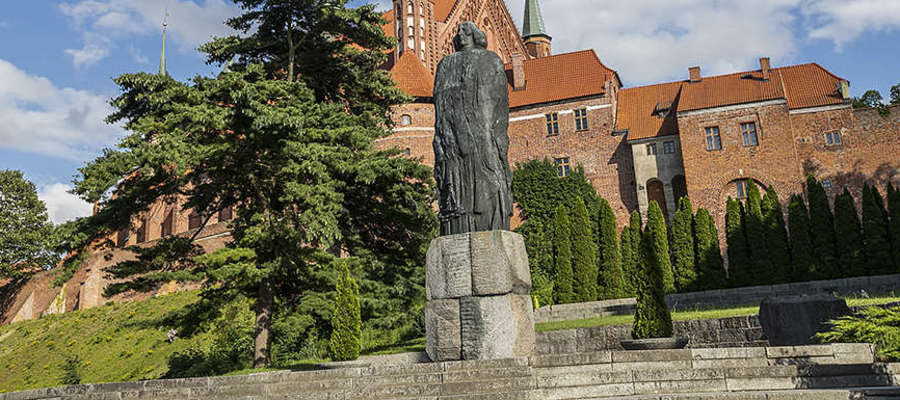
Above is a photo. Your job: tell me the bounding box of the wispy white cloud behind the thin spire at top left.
[59,0,240,67]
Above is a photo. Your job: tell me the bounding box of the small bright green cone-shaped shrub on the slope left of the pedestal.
[329,262,362,361]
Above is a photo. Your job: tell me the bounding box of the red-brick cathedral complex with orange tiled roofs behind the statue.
[0,0,900,324]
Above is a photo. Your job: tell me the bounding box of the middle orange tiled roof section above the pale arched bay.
[616,82,683,140]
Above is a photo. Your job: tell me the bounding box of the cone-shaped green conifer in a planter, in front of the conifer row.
[631,227,674,339]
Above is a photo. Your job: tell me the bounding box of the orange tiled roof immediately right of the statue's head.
[505,50,619,108]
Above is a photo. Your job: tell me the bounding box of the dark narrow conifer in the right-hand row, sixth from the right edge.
[762,185,792,283]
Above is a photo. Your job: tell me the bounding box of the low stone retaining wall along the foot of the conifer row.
[534,274,900,323]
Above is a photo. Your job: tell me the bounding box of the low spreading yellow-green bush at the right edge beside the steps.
[816,307,900,362]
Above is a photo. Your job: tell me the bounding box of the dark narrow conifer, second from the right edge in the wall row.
[862,185,896,275]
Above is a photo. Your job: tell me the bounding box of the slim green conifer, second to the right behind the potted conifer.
[694,208,726,290]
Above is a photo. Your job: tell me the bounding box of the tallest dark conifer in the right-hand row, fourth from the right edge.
[806,174,840,279]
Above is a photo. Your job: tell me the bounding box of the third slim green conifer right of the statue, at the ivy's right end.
[598,197,628,299]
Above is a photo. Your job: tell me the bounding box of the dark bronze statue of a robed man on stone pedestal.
[434,22,512,236]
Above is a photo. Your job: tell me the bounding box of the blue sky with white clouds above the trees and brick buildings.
[0,0,900,223]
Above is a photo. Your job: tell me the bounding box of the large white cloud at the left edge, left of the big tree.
[0,59,123,161]
